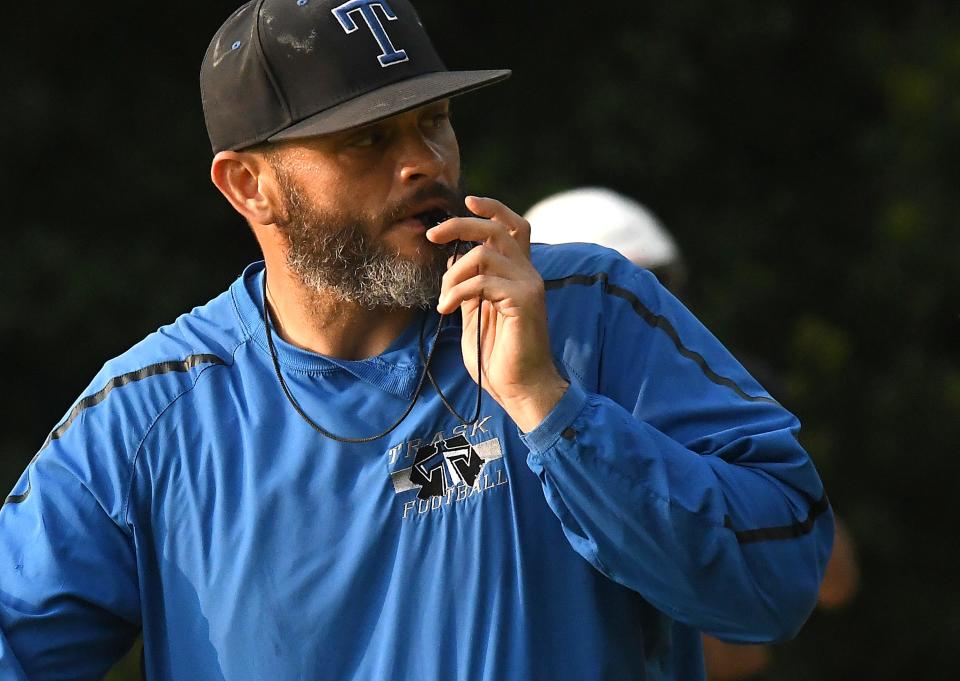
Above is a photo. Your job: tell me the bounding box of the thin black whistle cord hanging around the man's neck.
[263,241,483,444]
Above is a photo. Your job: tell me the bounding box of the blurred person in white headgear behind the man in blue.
[524,187,860,681]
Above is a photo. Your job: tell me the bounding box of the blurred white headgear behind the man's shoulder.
[525,187,680,269]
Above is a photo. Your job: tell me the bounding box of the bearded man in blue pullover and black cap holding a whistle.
[0,0,832,681]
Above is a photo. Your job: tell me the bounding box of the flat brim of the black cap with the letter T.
[268,70,511,142]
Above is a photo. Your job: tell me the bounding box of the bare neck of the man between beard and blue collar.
[267,268,416,359]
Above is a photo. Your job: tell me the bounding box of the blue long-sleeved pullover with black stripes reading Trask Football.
[0,245,833,681]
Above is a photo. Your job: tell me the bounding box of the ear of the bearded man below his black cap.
[210,151,281,226]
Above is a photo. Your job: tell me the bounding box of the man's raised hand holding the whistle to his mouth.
[427,196,569,432]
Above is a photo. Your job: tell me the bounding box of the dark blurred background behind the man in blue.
[0,0,960,681]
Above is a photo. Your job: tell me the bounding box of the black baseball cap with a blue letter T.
[200,0,510,153]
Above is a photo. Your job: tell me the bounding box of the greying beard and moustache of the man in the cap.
[276,167,464,309]
